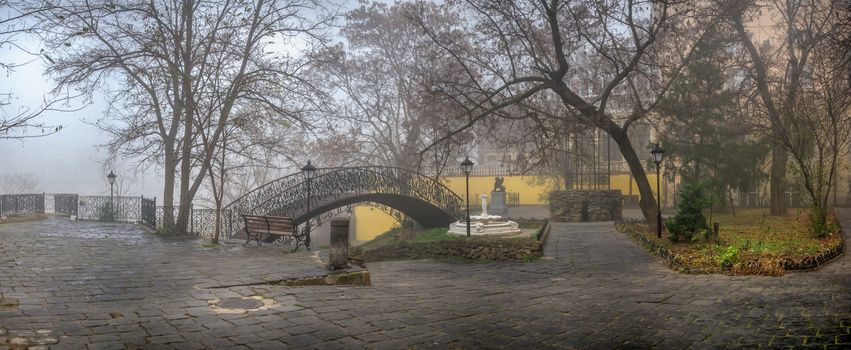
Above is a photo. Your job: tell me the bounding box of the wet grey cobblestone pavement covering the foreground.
[0,213,851,349]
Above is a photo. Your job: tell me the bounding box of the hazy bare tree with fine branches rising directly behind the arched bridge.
[317,1,472,173]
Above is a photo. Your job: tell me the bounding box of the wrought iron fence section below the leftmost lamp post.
[77,196,142,222]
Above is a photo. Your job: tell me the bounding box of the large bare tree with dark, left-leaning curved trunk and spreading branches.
[422,0,713,228]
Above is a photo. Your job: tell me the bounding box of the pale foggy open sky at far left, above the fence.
[0,37,162,198]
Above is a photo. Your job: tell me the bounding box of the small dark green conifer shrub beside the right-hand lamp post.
[665,182,710,242]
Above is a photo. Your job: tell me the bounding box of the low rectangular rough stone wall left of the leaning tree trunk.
[550,190,623,222]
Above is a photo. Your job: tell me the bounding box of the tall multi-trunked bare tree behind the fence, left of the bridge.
[33,0,328,231]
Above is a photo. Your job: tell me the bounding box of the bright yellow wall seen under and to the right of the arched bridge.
[352,174,664,241]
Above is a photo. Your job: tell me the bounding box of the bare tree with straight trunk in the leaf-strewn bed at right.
[718,0,839,215]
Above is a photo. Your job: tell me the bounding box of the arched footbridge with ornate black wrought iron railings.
[224,166,461,237]
